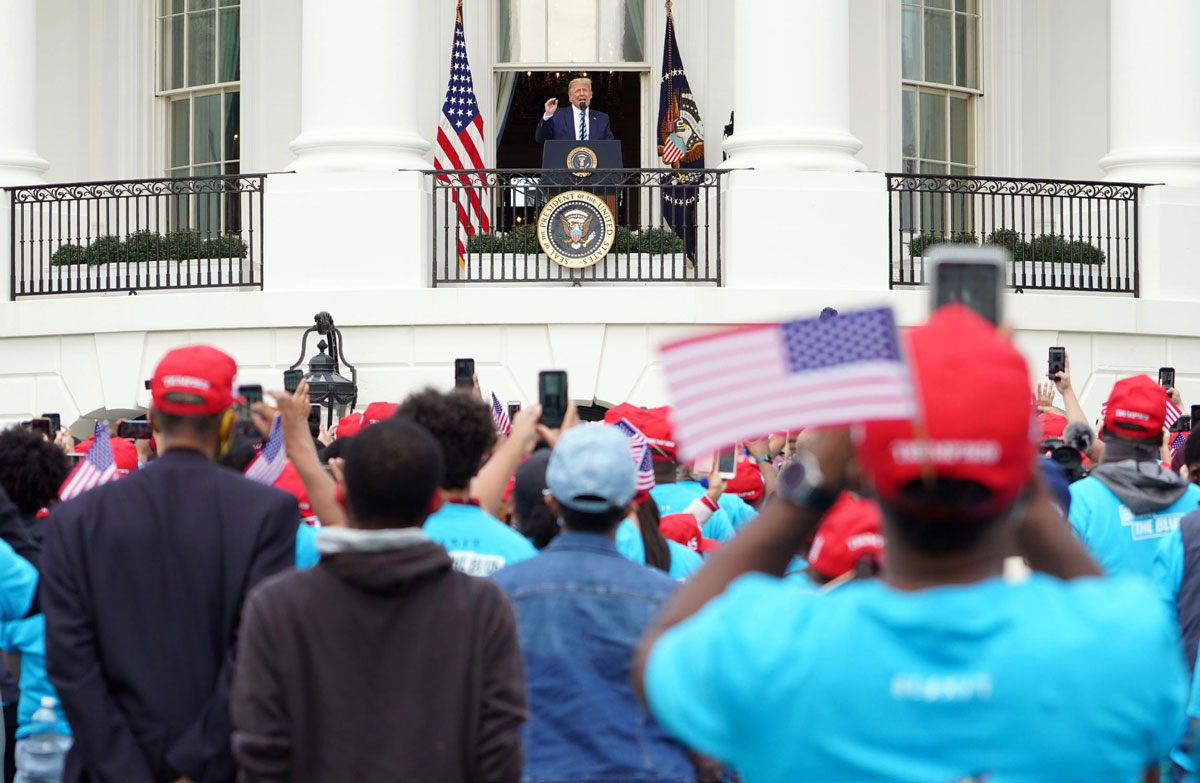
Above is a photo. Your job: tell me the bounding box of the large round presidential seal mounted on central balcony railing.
[538,190,617,269]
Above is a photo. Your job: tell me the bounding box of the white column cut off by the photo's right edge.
[1100,0,1200,186]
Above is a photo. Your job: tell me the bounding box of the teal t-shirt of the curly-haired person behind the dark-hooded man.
[425,503,538,576]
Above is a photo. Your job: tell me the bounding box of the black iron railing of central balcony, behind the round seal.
[426,168,726,286]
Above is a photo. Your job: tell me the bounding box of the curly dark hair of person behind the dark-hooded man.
[396,389,496,490]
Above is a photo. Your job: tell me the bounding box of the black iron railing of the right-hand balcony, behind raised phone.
[887,174,1141,297]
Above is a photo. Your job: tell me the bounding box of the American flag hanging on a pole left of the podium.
[433,0,491,265]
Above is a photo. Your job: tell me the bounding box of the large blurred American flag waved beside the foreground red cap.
[662,307,917,460]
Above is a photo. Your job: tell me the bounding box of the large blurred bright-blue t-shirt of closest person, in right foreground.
[646,574,1188,783]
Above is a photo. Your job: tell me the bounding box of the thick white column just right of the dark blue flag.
[724,0,864,172]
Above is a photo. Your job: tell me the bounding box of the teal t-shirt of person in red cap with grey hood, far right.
[1070,476,1200,576]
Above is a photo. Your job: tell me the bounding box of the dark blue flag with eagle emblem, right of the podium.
[658,0,704,262]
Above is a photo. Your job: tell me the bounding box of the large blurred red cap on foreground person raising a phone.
[856,304,1034,520]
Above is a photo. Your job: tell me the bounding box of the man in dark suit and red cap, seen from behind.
[41,346,299,783]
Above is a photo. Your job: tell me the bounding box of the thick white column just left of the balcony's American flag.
[290,0,430,172]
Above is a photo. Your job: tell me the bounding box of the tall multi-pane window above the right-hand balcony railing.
[900,0,982,232]
